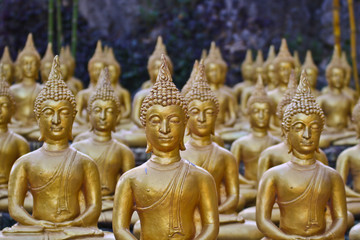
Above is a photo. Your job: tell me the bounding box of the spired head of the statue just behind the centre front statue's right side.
[185,60,219,137]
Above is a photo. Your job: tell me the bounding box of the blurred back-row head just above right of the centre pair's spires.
[204,42,227,85]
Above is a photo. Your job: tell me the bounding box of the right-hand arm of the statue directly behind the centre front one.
[219,156,239,213]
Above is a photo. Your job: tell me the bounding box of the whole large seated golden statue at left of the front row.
[0,56,114,240]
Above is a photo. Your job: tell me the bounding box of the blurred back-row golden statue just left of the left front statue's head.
[10,33,41,139]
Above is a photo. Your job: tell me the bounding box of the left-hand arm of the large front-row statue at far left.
[8,159,55,227]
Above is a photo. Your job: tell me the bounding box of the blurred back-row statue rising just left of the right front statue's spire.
[268,38,295,132]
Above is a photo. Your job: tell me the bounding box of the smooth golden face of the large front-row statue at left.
[38,100,74,141]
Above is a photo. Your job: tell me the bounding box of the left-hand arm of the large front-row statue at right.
[256,172,305,240]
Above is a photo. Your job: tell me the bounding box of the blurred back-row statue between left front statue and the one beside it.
[76,40,106,125]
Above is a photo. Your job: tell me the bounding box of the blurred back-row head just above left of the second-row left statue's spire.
[88,40,106,85]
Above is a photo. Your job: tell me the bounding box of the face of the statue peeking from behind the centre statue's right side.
[187,100,216,137]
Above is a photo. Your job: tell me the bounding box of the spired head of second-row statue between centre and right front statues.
[247,74,274,130]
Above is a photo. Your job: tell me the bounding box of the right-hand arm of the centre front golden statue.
[195,173,219,240]
